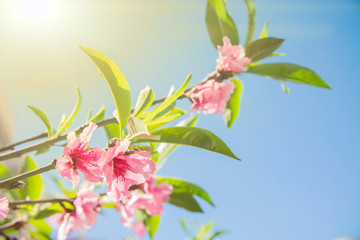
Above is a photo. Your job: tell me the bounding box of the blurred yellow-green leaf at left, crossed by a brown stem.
[19,156,44,200]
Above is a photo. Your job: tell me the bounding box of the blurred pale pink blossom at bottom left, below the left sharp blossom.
[50,182,99,240]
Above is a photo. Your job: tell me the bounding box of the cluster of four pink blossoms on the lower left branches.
[52,123,172,239]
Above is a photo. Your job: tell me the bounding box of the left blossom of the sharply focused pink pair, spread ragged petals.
[56,122,103,188]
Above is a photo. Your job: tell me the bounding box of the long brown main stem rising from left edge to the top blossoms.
[0,71,237,161]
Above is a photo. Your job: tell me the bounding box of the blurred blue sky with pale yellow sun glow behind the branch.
[0,0,360,240]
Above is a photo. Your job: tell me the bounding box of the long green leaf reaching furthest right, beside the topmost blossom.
[247,63,331,89]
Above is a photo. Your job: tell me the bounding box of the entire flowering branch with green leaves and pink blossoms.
[0,0,330,239]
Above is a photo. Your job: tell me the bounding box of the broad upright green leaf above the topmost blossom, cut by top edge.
[206,0,239,49]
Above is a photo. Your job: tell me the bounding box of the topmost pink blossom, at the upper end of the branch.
[216,36,251,72]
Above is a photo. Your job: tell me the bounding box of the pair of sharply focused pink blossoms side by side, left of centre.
[56,123,155,202]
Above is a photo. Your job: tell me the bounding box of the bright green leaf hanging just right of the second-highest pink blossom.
[224,78,244,129]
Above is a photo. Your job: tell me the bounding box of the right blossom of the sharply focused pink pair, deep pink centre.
[99,139,155,202]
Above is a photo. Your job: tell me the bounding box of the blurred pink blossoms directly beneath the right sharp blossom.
[116,178,173,236]
